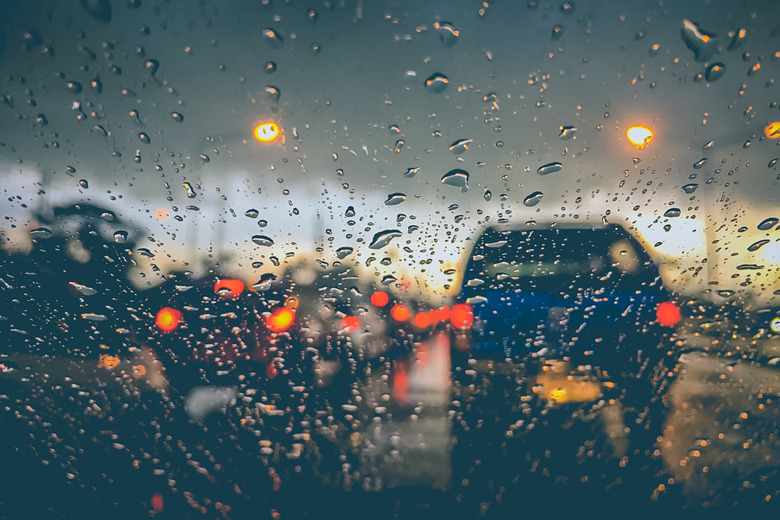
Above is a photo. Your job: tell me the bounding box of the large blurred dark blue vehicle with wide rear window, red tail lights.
[456,224,681,402]
